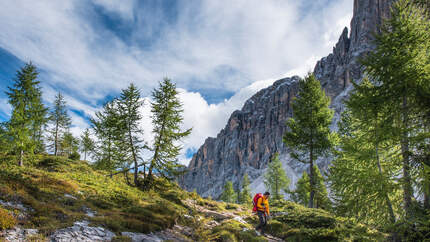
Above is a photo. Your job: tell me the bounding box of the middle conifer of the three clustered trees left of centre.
[118,84,144,186]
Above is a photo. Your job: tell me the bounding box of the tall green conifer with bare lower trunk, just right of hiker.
[283,74,335,208]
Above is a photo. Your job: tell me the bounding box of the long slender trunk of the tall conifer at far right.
[401,95,412,219]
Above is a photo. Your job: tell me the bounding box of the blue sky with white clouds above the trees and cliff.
[0,0,353,164]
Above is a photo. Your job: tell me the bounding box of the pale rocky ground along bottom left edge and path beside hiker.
[0,199,283,242]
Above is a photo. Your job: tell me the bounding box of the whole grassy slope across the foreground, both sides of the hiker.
[0,156,383,241]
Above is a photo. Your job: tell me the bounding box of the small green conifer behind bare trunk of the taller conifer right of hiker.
[288,166,331,210]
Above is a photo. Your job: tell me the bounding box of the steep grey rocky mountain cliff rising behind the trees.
[180,0,393,198]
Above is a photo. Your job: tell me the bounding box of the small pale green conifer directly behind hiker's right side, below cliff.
[264,153,290,200]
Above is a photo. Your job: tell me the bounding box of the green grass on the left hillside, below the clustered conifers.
[0,156,188,234]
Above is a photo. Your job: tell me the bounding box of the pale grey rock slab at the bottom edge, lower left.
[50,221,115,242]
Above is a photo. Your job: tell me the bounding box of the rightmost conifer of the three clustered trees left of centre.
[145,78,191,189]
